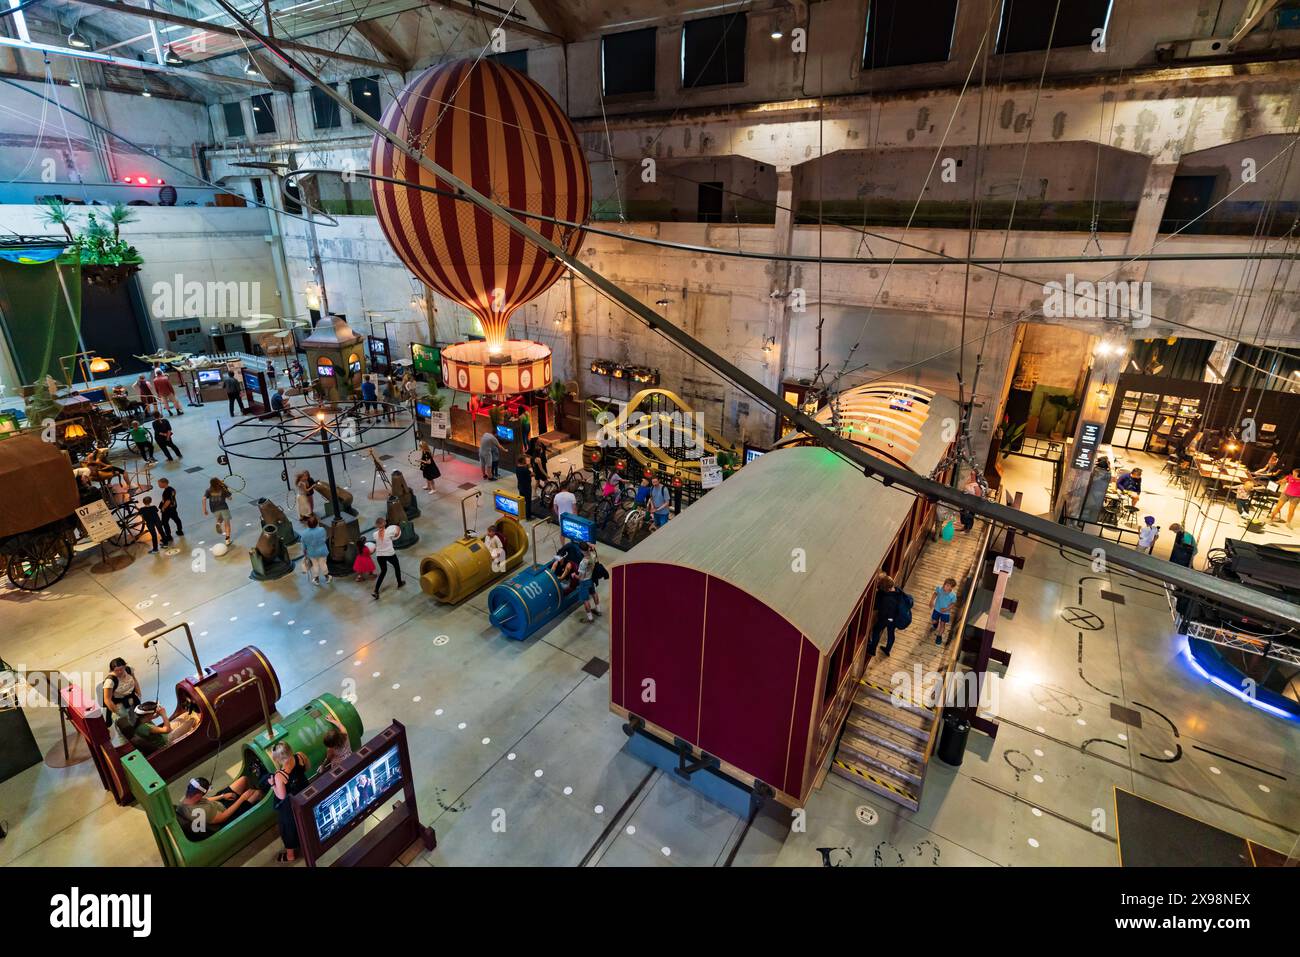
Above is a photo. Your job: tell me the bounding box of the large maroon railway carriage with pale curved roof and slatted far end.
[610,385,958,806]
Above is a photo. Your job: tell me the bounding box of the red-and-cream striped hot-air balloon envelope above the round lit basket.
[371,60,592,354]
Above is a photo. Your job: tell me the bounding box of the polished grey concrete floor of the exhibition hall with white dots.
[0,395,1300,867]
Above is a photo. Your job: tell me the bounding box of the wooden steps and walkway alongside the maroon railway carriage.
[831,521,988,810]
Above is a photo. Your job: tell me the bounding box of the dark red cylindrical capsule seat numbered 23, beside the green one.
[62,645,280,805]
